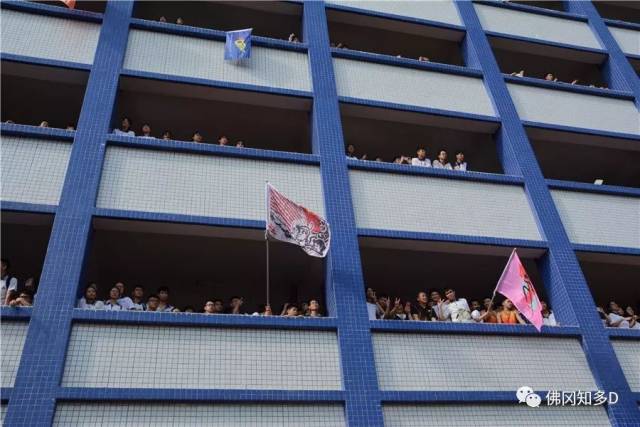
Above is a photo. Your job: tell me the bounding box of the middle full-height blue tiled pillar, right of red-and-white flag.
[303,1,382,426]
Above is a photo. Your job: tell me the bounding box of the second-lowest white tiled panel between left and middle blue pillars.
[62,324,342,390]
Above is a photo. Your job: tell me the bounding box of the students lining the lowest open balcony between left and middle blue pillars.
[77,282,323,317]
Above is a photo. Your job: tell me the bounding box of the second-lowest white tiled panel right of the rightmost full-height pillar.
[551,190,640,249]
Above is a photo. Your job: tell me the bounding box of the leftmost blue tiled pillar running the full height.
[5,1,133,427]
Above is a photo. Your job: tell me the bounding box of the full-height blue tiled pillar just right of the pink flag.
[456,1,640,426]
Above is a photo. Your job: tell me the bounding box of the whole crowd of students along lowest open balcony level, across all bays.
[0,259,640,330]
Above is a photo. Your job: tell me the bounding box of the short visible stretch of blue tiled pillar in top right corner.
[565,1,640,103]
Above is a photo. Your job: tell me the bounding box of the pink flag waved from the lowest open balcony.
[496,249,542,332]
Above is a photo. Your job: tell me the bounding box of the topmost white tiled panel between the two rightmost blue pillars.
[474,4,601,49]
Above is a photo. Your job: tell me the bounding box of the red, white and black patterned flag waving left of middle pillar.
[266,183,331,258]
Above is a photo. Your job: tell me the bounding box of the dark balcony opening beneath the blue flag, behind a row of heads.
[112,76,312,153]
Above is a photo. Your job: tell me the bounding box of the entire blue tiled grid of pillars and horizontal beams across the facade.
[0,1,640,426]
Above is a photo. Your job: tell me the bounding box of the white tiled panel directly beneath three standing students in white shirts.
[349,170,541,240]
